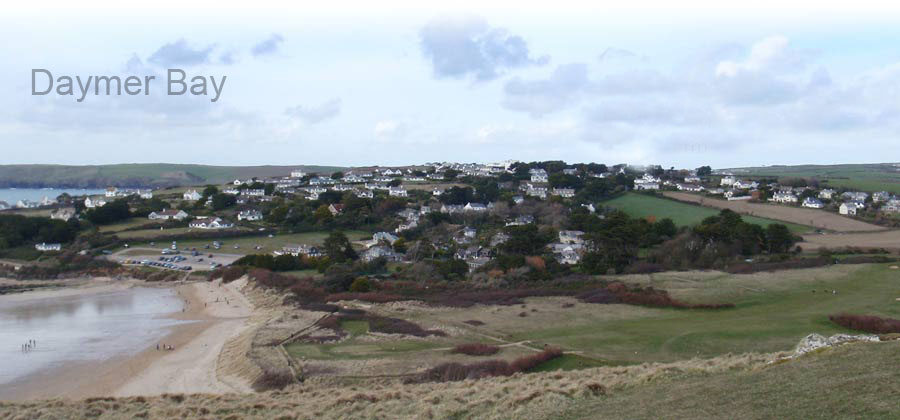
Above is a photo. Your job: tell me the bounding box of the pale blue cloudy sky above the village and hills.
[0,0,900,168]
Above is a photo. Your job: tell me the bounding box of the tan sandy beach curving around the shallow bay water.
[5,280,253,400]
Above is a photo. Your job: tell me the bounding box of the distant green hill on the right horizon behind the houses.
[720,163,900,194]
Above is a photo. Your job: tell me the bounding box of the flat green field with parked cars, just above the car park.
[119,228,372,254]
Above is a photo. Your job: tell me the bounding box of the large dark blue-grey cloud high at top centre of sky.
[419,16,549,81]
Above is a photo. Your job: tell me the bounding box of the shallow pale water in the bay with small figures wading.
[0,287,184,400]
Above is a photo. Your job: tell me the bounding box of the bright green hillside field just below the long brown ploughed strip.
[603,193,812,233]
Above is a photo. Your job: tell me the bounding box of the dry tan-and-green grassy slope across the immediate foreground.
[0,342,900,420]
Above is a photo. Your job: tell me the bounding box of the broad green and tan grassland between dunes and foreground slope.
[288,264,900,371]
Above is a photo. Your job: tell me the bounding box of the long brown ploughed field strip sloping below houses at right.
[663,191,885,232]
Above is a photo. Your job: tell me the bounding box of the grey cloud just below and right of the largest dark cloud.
[503,63,590,117]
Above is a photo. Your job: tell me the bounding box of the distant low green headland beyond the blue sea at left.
[0,163,343,188]
